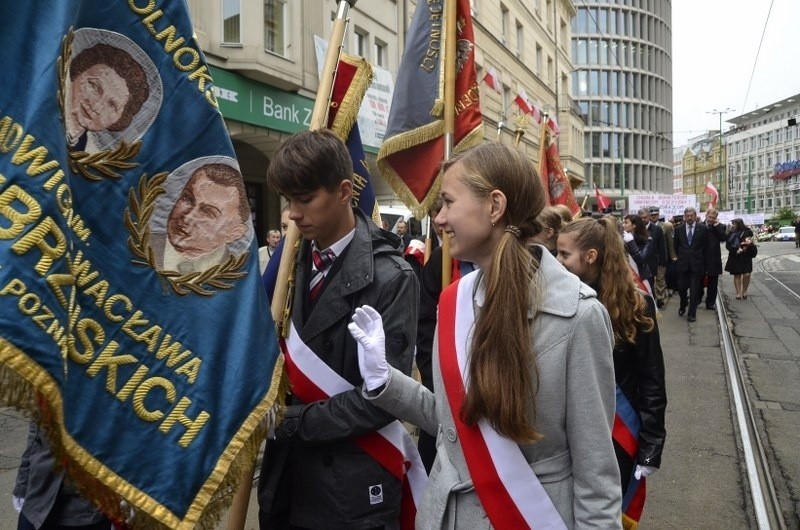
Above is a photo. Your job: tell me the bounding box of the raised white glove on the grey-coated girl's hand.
[347,305,389,390]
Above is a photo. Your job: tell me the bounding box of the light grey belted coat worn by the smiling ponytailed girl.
[372,251,621,530]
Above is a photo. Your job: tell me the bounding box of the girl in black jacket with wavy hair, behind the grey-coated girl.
[558,214,667,520]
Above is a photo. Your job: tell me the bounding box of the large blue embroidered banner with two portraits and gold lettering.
[0,0,278,528]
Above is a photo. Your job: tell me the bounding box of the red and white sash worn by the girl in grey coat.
[439,274,566,530]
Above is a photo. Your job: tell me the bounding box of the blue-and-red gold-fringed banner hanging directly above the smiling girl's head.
[378,0,483,218]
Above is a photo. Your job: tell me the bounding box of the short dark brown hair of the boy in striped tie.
[267,129,353,196]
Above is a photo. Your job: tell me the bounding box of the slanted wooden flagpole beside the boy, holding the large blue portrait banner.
[222,0,356,530]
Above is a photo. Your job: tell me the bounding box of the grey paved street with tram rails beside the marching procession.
[0,243,800,530]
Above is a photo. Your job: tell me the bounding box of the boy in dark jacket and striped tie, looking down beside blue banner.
[258,129,419,529]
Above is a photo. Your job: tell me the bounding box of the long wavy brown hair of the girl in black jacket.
[561,216,654,346]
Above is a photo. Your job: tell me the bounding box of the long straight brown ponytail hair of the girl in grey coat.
[444,142,545,443]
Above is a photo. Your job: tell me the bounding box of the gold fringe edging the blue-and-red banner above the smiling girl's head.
[378,121,483,218]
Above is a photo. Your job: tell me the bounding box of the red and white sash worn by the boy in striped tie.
[280,324,428,529]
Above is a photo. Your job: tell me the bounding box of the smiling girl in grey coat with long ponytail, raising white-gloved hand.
[350,143,621,529]
